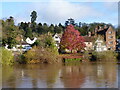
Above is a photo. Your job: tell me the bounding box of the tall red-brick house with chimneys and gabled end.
[95,26,116,50]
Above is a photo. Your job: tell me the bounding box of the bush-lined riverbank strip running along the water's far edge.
[2,47,120,65]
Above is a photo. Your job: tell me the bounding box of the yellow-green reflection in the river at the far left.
[2,66,21,88]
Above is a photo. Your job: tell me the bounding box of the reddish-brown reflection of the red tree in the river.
[61,66,85,88]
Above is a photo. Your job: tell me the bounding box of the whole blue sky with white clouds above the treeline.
[0,0,118,25]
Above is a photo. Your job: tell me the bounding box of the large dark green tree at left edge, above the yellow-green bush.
[2,17,22,48]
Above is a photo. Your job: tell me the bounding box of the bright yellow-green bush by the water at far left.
[0,48,14,65]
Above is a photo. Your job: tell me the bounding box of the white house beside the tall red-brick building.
[94,39,107,52]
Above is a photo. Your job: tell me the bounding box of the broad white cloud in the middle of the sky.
[29,0,102,23]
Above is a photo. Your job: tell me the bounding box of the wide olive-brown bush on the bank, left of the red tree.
[24,47,60,63]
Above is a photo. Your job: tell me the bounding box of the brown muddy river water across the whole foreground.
[2,63,120,88]
